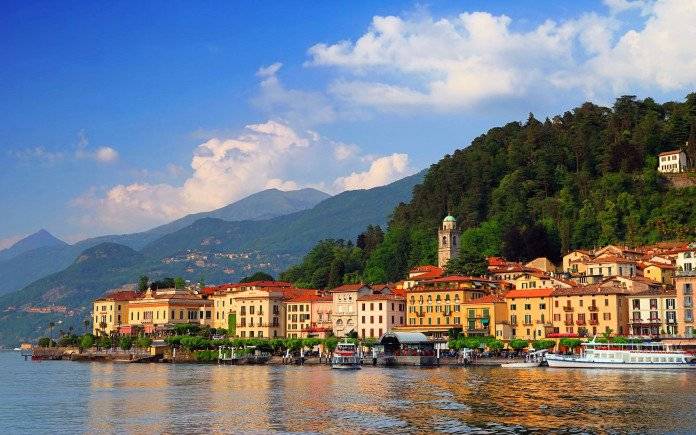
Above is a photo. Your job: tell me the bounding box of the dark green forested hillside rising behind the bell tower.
[286,93,696,282]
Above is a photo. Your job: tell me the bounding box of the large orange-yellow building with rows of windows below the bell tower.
[400,276,500,338]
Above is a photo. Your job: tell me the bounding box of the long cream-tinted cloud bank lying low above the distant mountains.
[72,121,411,235]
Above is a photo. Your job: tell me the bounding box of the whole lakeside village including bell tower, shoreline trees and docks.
[28,206,696,365]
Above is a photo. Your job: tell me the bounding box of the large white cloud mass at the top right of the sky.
[306,0,696,111]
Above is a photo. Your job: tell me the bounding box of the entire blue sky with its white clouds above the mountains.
[0,0,696,245]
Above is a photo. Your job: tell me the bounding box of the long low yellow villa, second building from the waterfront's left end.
[125,289,213,334]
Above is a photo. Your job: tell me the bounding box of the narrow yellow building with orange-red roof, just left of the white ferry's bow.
[505,288,555,340]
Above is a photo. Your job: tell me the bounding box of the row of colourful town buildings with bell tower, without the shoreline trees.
[92,216,696,341]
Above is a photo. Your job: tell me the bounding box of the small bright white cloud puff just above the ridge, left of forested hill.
[334,153,413,192]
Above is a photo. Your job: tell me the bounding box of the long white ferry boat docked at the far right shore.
[546,340,696,369]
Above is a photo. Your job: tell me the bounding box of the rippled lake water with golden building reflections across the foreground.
[0,352,696,433]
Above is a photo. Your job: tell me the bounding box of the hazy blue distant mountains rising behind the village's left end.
[0,171,425,345]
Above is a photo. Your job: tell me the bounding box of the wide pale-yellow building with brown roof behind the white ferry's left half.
[552,285,630,337]
